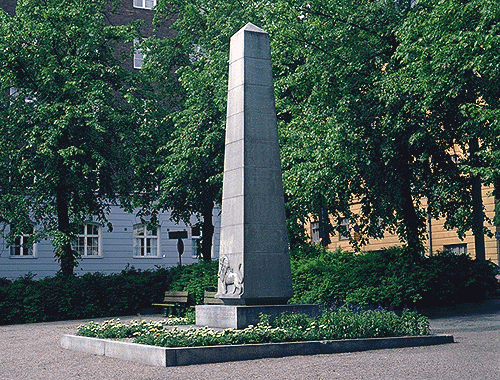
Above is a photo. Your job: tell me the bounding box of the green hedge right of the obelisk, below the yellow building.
[290,248,497,309]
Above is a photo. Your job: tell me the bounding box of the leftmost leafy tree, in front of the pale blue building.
[0,0,137,276]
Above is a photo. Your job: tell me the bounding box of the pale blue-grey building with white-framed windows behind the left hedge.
[0,206,220,279]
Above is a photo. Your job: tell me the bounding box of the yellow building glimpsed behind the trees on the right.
[306,187,500,264]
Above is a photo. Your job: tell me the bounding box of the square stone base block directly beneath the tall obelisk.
[195,305,319,329]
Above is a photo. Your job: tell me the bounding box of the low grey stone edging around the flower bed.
[61,335,454,367]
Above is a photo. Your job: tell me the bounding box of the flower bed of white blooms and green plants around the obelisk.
[78,306,430,347]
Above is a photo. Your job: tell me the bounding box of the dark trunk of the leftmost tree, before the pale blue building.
[54,187,77,277]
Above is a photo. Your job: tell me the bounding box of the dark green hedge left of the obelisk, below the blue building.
[0,262,217,324]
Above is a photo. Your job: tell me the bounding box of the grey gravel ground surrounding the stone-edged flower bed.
[0,300,500,380]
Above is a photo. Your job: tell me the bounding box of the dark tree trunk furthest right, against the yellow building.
[469,138,486,261]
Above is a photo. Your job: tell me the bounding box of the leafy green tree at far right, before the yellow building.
[392,0,500,260]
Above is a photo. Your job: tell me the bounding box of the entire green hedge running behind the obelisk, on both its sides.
[0,246,498,324]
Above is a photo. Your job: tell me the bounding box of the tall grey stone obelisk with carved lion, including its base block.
[196,23,317,328]
